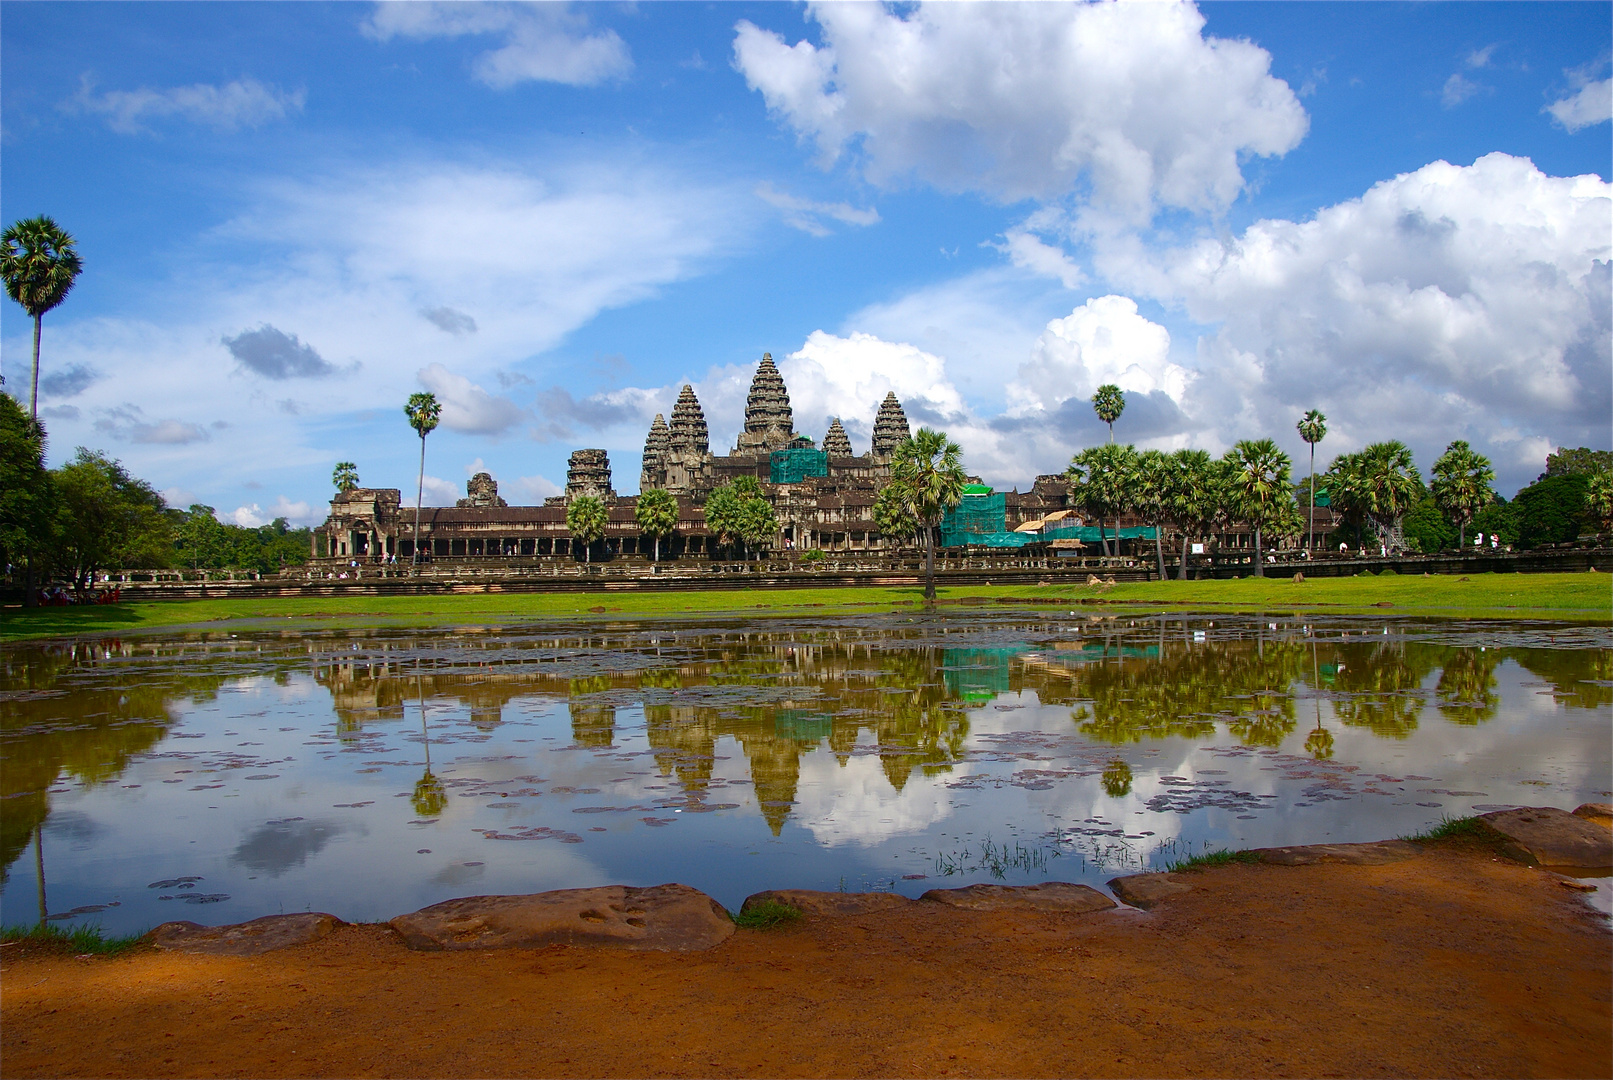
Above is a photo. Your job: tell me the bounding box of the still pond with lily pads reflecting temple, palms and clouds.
[0,611,1613,933]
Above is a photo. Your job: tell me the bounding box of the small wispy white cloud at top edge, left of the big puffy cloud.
[363,0,632,89]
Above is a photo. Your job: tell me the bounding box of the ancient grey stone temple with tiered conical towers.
[313,353,1073,566]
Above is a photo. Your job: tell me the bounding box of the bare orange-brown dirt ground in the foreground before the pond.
[0,846,1613,1077]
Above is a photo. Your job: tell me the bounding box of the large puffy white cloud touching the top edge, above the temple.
[734,3,1308,221]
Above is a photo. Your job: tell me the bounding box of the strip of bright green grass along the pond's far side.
[0,574,1613,642]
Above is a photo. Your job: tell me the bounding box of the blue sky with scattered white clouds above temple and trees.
[0,0,1613,525]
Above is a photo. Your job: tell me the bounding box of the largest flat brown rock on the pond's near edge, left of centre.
[392,885,734,953]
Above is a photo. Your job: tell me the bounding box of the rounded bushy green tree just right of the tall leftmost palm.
[52,447,173,596]
